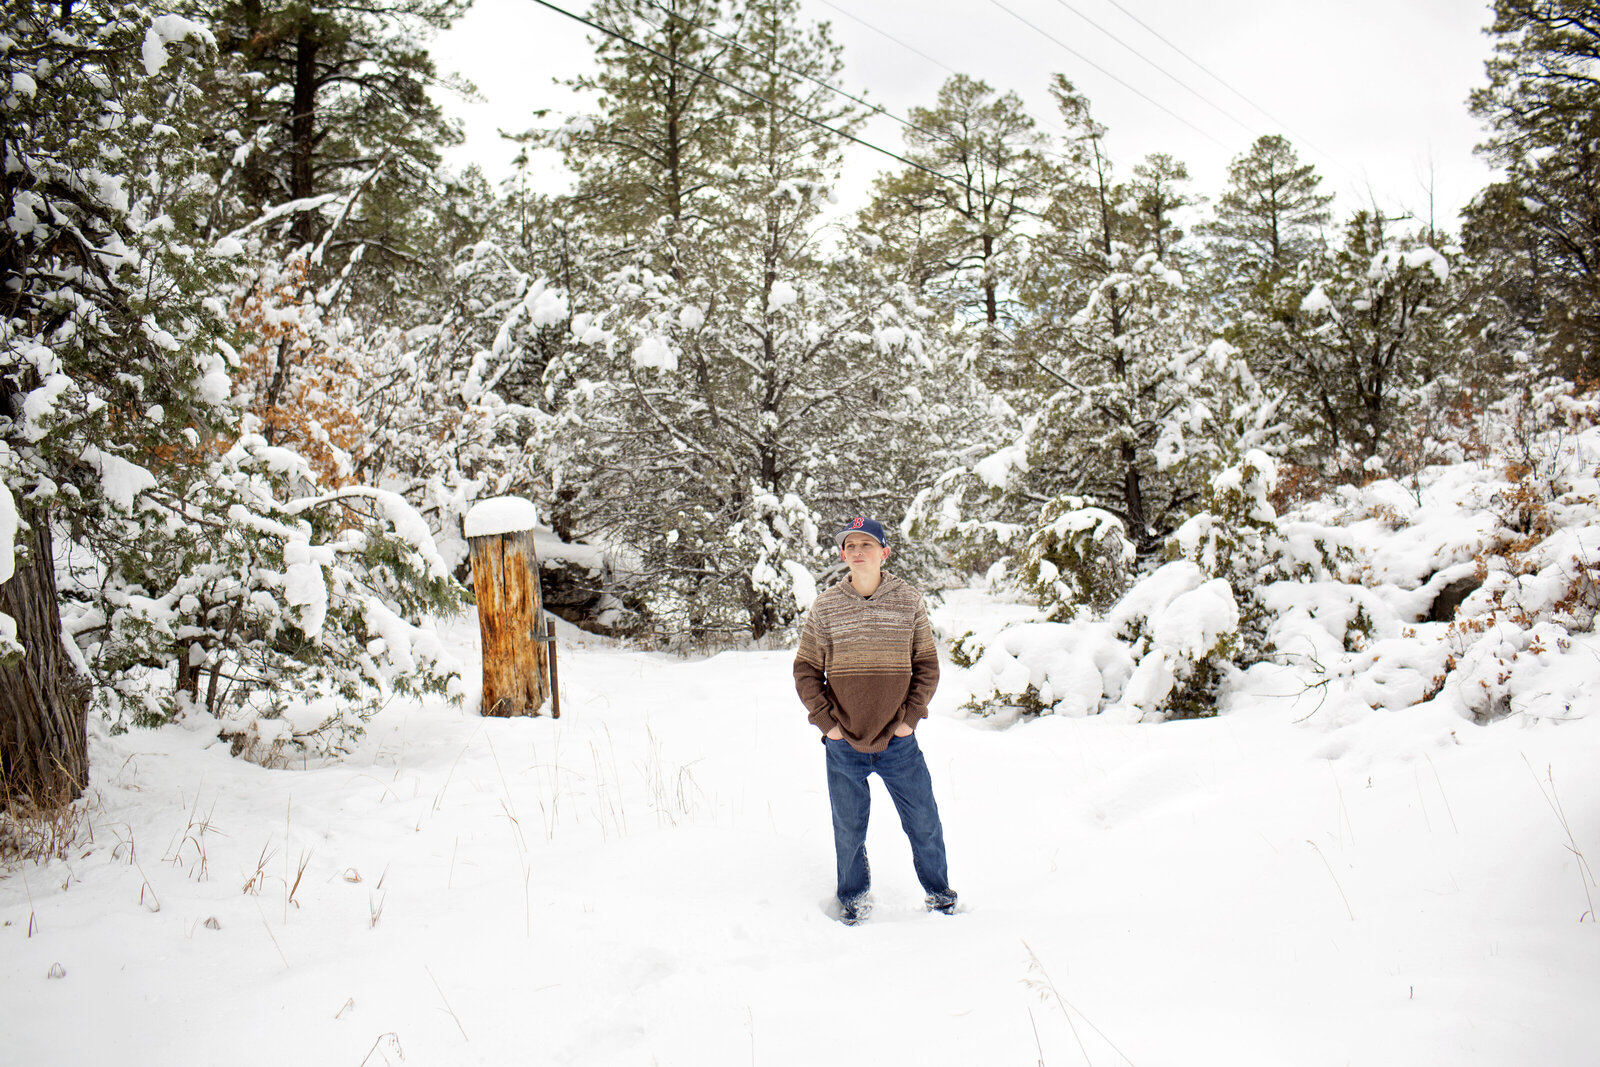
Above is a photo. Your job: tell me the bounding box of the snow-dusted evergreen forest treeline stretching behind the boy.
[0,0,1600,797]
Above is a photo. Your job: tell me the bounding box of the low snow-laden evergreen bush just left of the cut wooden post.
[64,435,464,761]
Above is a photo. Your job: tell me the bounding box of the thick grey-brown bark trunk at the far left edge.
[0,506,90,808]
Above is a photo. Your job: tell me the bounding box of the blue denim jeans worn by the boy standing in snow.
[822,734,955,909]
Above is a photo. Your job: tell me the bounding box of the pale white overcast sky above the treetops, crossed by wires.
[434,0,1491,226]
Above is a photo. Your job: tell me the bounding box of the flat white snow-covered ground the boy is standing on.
[0,592,1600,1067]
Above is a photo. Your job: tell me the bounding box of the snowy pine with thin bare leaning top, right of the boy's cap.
[1026,78,1264,558]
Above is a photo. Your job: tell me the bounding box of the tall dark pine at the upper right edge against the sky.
[1467,0,1600,376]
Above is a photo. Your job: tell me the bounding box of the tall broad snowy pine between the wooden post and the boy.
[547,0,947,640]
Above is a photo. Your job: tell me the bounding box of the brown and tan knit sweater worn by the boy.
[795,571,939,752]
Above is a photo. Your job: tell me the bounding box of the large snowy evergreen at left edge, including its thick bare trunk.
[0,0,230,806]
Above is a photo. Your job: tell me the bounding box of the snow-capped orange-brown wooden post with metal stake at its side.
[466,496,560,717]
